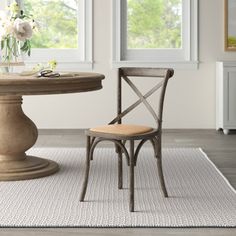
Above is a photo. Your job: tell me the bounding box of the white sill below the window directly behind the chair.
[112,61,199,70]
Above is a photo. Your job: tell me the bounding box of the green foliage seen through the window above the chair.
[127,0,182,48]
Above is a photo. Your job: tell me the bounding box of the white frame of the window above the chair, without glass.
[112,0,199,69]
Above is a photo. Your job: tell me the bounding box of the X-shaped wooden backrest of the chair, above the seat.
[109,67,174,128]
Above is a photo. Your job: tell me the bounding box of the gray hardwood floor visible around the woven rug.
[0,130,236,236]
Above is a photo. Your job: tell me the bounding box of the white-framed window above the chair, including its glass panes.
[113,0,198,68]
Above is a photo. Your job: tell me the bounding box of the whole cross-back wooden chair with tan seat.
[80,68,174,212]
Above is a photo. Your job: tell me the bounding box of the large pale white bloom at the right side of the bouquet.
[14,18,33,41]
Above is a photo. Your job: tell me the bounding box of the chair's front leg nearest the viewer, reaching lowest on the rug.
[129,140,134,212]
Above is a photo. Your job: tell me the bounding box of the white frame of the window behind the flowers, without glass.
[17,0,93,70]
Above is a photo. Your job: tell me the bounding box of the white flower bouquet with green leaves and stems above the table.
[0,1,36,64]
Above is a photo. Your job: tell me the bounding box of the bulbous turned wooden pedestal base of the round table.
[0,96,59,181]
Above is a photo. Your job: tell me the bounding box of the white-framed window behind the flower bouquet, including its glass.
[18,0,92,69]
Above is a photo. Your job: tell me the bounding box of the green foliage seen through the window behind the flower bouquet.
[24,0,78,48]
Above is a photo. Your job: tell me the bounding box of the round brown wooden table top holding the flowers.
[0,72,105,96]
